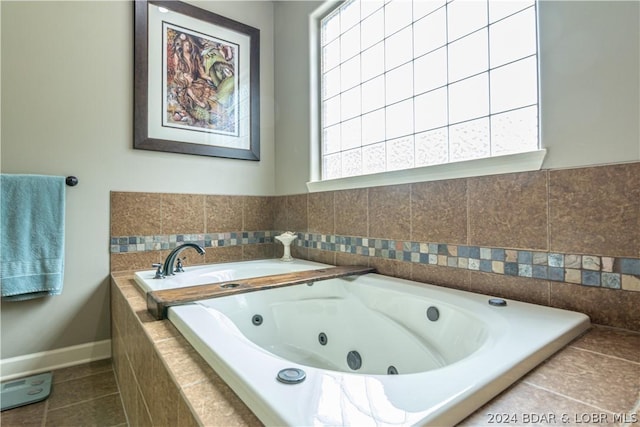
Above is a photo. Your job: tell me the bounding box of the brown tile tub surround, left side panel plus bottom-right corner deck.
[111,272,640,426]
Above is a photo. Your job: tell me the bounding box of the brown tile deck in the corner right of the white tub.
[458,327,640,427]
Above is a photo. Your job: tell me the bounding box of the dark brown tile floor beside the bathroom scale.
[0,359,128,427]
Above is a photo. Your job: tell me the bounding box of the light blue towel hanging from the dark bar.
[0,174,65,301]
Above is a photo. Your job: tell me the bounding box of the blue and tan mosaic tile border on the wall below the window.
[295,233,640,291]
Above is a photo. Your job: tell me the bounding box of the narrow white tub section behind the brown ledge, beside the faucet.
[134,259,327,292]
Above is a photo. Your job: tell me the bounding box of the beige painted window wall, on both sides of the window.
[275,0,640,194]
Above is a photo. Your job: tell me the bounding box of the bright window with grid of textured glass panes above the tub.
[320,0,539,180]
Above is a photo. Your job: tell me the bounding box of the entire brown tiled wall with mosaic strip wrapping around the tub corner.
[111,163,640,330]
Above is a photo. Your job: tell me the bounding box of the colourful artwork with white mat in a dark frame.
[133,0,260,160]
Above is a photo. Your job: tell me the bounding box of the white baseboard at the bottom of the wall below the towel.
[0,340,111,381]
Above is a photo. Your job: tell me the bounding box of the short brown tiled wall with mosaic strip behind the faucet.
[110,192,274,271]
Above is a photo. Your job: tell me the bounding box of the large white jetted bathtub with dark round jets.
[164,261,589,426]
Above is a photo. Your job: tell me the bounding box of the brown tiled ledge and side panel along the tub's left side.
[111,273,260,427]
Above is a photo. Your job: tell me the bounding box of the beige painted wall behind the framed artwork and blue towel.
[1,1,274,359]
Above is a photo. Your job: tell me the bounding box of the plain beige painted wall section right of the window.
[539,1,640,168]
